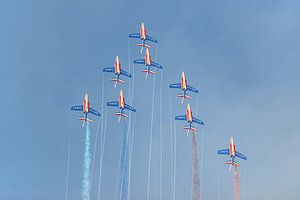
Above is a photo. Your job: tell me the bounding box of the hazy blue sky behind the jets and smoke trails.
[0,0,300,200]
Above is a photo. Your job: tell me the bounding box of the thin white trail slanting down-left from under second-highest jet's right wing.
[147,70,156,200]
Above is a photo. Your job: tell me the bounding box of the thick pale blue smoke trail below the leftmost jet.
[82,122,92,200]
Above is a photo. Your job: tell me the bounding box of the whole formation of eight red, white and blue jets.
[71,23,247,170]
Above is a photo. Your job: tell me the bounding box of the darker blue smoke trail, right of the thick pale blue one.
[119,122,128,200]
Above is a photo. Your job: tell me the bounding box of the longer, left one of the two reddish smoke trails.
[192,134,200,200]
